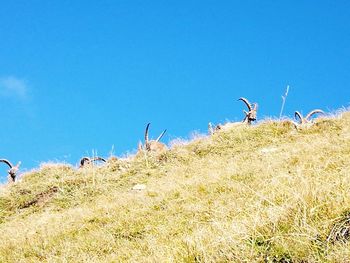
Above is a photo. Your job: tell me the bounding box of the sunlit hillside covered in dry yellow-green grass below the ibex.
[0,113,350,262]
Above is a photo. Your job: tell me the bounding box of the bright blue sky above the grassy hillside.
[0,0,350,182]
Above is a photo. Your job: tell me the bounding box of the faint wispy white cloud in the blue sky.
[0,76,28,100]
